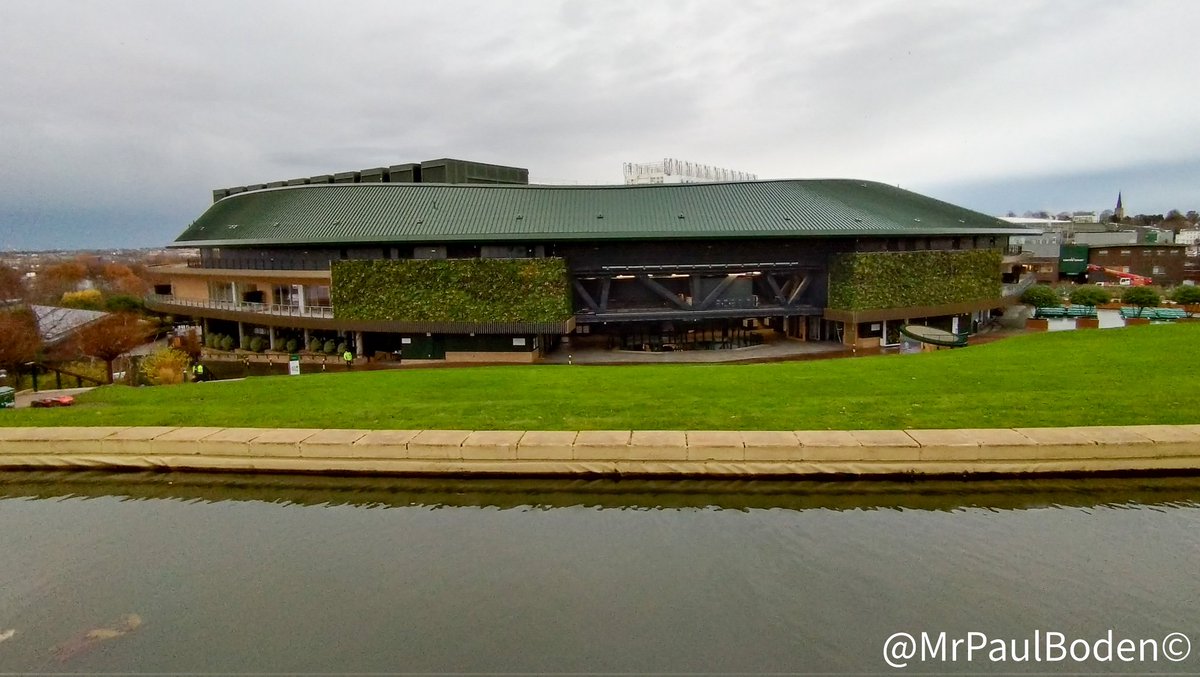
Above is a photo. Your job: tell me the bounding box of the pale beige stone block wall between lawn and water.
[0,425,1200,477]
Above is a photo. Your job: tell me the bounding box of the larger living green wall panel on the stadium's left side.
[331,258,571,322]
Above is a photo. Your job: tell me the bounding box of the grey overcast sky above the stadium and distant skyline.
[0,0,1200,248]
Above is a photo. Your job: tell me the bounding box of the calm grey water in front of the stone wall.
[0,473,1200,673]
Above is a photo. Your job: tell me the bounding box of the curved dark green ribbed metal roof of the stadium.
[175,179,1027,246]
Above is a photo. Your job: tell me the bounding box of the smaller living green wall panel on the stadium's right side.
[829,250,1001,310]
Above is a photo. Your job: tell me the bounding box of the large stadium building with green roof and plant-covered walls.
[148,160,1028,361]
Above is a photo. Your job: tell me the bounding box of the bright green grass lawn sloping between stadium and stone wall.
[0,323,1200,430]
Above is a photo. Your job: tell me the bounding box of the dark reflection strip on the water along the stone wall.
[0,471,1200,510]
